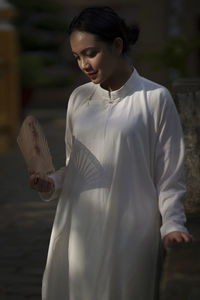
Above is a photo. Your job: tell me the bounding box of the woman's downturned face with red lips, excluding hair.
[70,31,121,87]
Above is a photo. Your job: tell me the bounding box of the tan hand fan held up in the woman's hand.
[17,116,55,174]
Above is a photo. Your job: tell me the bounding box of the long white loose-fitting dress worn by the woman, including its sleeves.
[42,70,187,300]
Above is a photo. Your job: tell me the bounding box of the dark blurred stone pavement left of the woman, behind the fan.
[0,110,65,300]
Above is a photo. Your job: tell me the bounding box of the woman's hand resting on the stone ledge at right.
[163,231,194,251]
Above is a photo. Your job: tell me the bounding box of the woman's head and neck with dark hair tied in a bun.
[69,7,139,90]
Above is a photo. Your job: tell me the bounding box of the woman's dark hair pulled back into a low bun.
[69,6,139,53]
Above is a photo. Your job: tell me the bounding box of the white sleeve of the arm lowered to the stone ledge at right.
[155,90,188,238]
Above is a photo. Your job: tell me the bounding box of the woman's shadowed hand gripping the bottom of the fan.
[28,170,54,193]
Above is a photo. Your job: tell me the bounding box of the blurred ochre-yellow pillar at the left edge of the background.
[0,1,19,155]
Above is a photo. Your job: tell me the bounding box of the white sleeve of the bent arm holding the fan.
[39,94,73,201]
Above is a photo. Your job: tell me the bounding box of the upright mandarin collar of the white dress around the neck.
[96,68,138,103]
